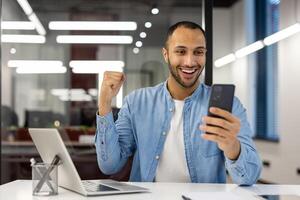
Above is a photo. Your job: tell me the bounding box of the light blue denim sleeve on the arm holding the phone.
[225,98,262,185]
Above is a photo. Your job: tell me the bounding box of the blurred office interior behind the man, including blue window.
[1,0,300,184]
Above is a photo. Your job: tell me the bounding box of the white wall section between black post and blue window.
[213,0,254,130]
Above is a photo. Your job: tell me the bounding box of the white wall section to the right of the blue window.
[257,0,300,184]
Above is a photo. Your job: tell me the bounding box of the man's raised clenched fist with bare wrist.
[98,71,125,116]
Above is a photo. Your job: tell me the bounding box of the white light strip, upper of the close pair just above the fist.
[69,60,125,68]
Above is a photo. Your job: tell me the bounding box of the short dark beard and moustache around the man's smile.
[168,58,204,88]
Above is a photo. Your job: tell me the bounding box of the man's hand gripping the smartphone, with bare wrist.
[199,107,241,160]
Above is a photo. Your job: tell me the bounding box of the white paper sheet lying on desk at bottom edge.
[182,192,257,200]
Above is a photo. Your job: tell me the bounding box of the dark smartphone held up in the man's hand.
[207,84,235,118]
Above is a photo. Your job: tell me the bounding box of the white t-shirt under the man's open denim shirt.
[155,100,191,183]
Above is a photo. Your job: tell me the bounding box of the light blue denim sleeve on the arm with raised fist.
[95,97,135,174]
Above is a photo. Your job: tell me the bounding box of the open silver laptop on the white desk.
[28,128,149,196]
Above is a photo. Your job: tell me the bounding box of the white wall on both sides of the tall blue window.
[213,0,300,184]
